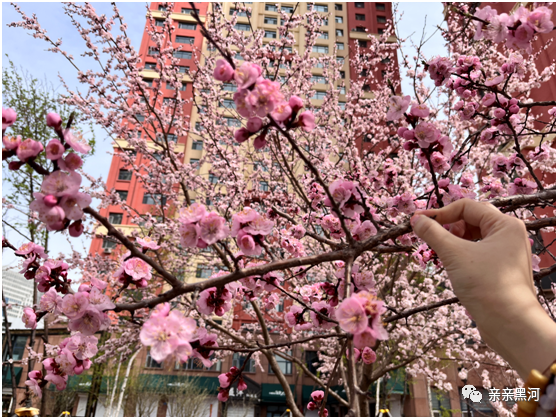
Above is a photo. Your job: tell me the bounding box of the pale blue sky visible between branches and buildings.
[2,2,445,266]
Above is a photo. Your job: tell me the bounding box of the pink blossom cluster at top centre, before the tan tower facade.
[213,59,316,150]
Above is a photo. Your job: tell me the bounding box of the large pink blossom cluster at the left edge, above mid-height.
[2,108,91,237]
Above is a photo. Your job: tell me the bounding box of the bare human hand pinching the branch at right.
[411,199,556,378]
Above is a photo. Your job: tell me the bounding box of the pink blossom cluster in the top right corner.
[475,6,554,53]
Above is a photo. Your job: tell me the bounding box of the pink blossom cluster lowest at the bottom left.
[25,333,98,397]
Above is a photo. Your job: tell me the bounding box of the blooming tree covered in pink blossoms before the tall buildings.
[2,4,556,416]
